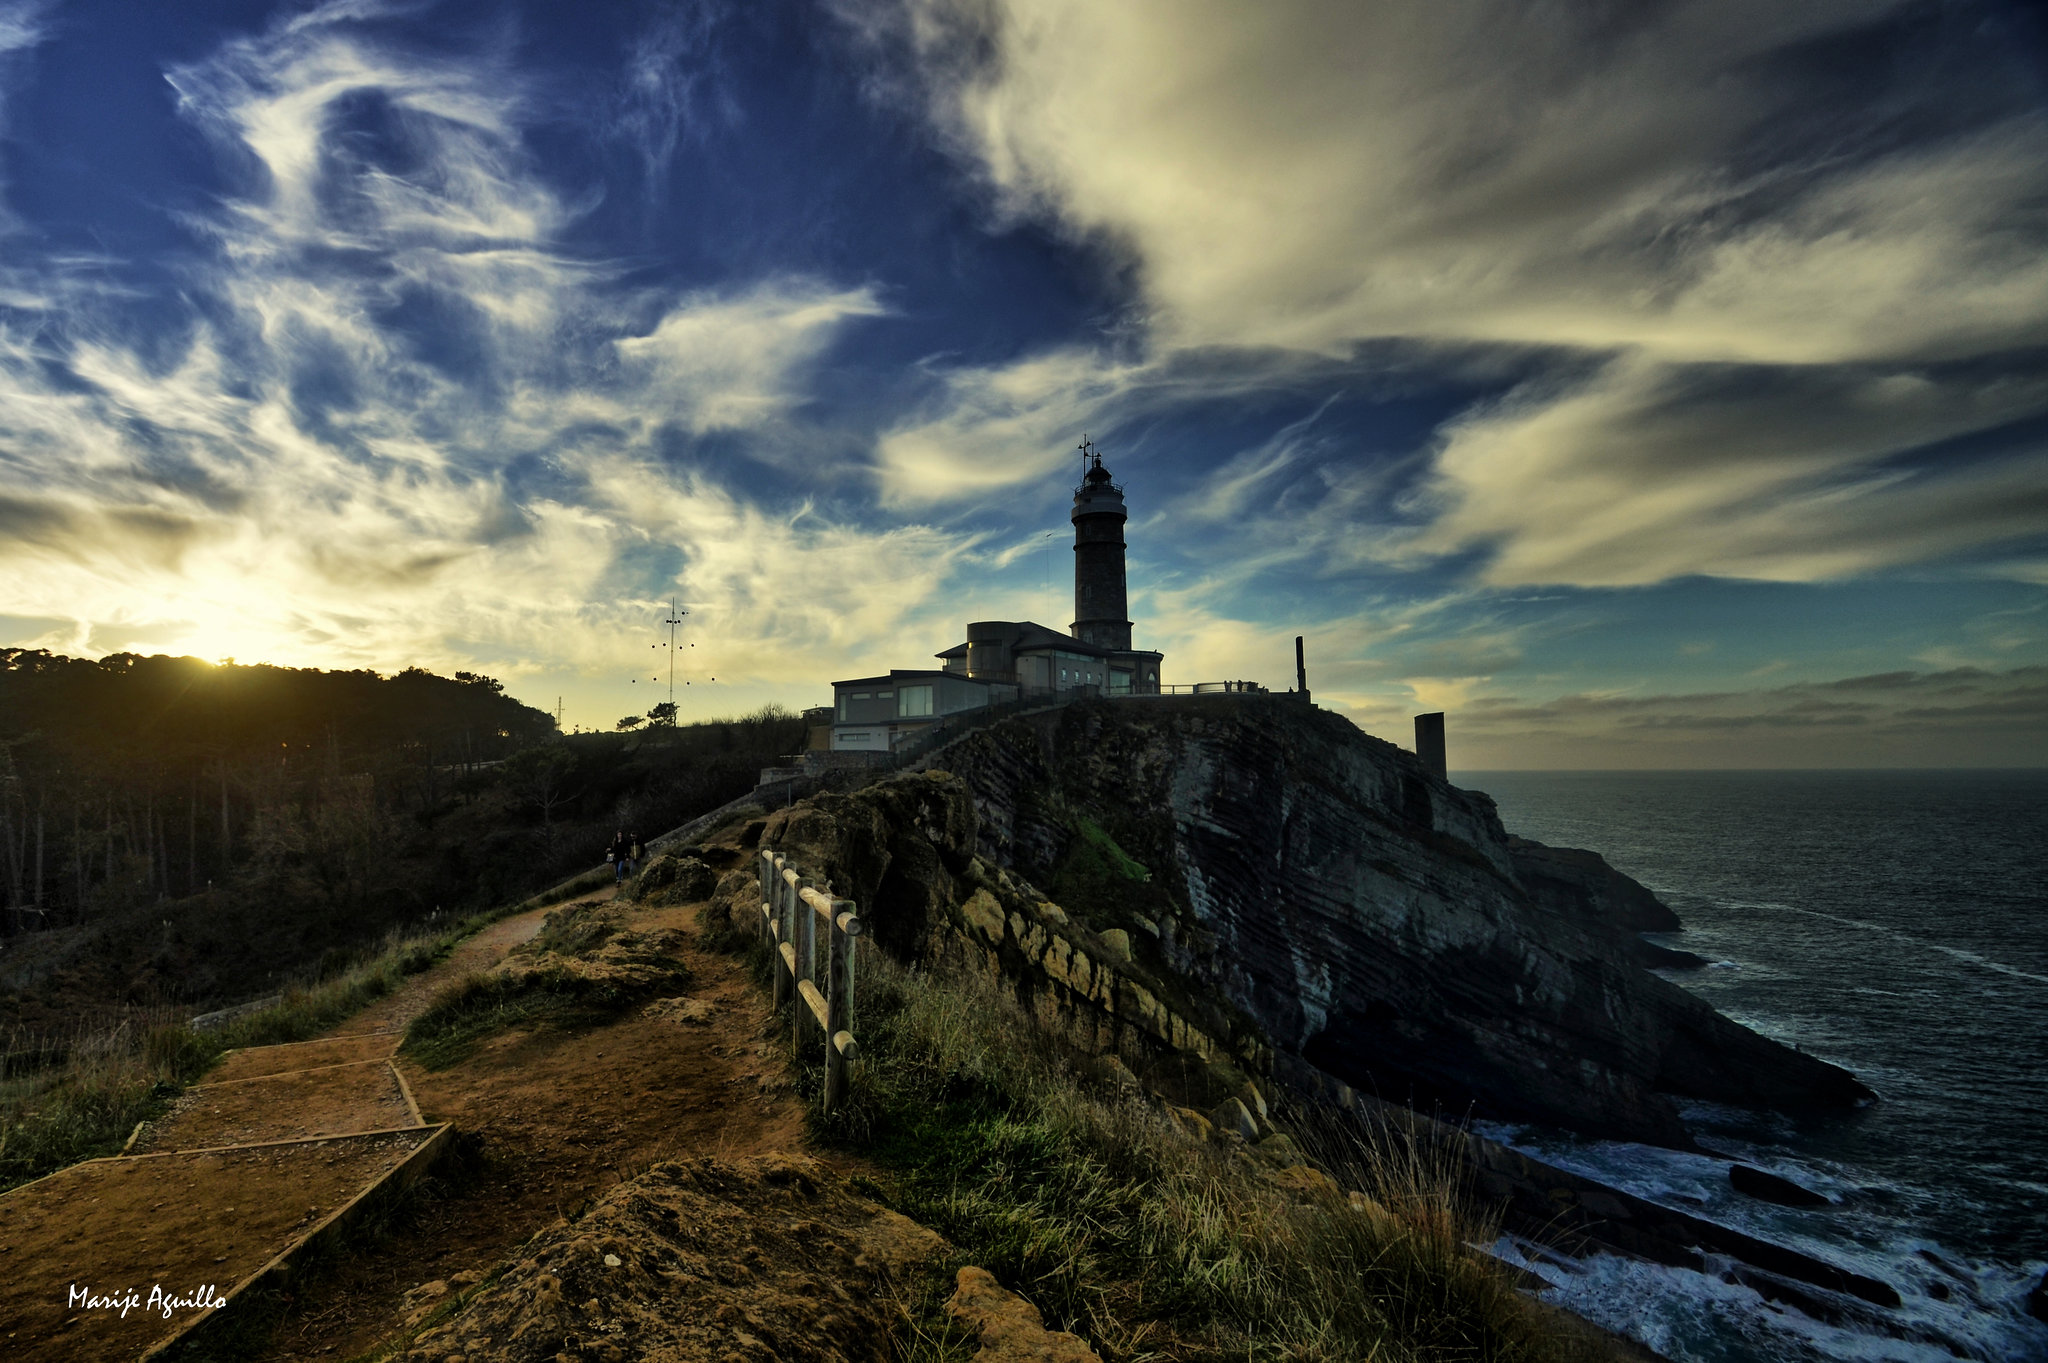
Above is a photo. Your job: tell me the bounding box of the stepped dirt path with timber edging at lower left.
[0,875,647,1363]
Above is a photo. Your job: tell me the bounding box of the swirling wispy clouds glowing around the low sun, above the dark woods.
[0,4,917,720]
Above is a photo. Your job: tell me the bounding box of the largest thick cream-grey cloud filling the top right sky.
[907,0,2048,360]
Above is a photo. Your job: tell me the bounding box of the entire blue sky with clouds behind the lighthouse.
[0,0,2048,770]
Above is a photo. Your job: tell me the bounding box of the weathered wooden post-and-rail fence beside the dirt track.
[756,847,860,1111]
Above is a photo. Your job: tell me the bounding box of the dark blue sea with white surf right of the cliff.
[1452,770,2048,1363]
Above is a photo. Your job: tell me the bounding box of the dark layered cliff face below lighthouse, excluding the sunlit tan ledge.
[942,696,1870,1146]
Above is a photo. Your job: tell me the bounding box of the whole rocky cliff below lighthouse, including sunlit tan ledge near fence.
[768,696,1872,1146]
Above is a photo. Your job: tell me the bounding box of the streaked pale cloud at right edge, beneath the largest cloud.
[1413,358,2048,585]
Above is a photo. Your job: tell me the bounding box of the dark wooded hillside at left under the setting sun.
[0,651,801,1031]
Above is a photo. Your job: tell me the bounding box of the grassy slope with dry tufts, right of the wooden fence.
[798,956,1585,1363]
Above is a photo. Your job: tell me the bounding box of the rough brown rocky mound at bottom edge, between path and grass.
[406,1156,944,1363]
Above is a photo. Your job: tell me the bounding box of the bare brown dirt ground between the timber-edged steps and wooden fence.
[243,843,803,1361]
